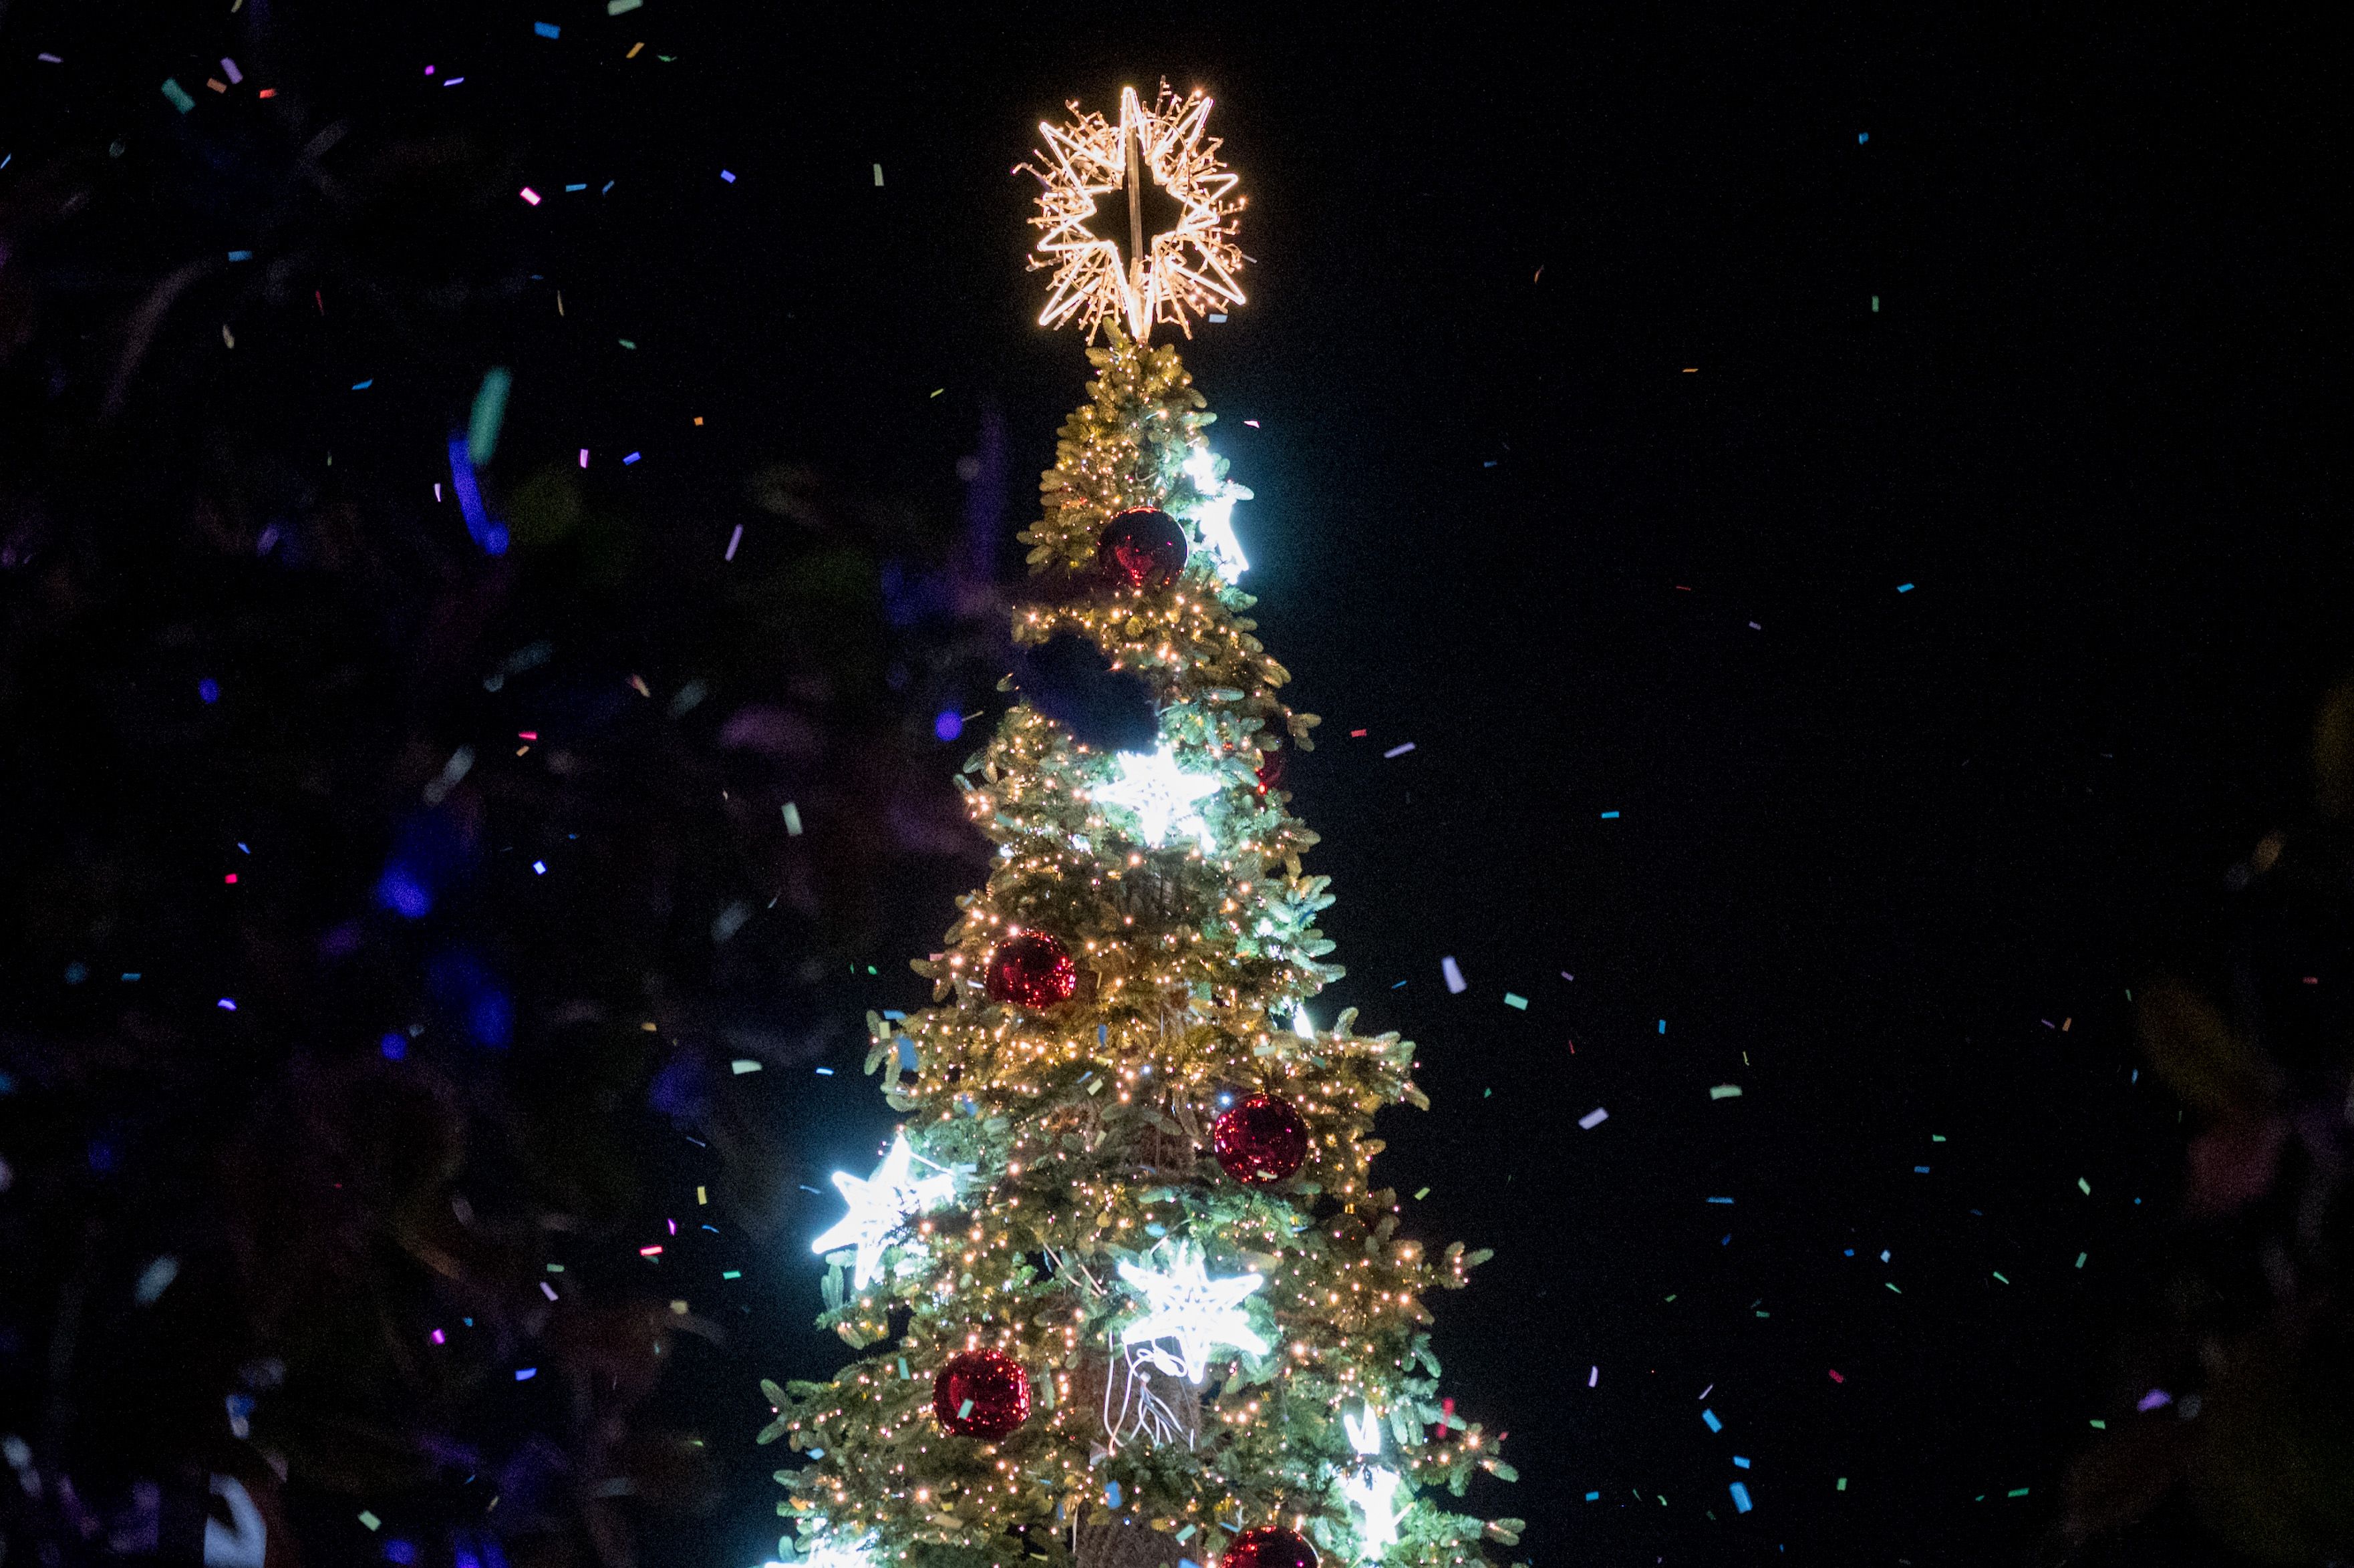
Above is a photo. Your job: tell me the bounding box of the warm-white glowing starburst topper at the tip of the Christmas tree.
[1022,82,1243,344]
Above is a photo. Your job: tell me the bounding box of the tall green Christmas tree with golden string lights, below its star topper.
[762,332,1518,1568]
